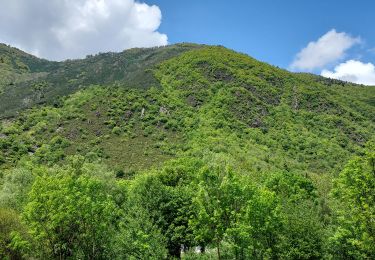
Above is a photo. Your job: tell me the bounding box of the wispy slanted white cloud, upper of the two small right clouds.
[290,29,361,71]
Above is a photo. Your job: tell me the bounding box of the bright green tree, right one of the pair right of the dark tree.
[227,189,283,259]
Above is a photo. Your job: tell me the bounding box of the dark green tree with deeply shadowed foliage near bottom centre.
[125,157,202,258]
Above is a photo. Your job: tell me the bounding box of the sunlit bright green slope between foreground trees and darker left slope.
[1,46,375,178]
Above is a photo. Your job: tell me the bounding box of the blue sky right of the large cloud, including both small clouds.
[148,0,375,85]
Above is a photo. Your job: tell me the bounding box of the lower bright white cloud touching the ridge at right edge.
[321,60,375,86]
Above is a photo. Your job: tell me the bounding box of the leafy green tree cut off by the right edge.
[330,145,375,259]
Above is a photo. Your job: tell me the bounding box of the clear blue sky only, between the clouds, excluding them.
[147,0,375,68]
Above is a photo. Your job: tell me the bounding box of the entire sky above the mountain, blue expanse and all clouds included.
[0,0,375,85]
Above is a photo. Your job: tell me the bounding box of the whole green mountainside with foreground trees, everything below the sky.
[0,44,375,259]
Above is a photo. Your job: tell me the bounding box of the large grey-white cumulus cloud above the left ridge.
[0,0,168,60]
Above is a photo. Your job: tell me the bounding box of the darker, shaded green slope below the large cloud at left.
[0,44,200,118]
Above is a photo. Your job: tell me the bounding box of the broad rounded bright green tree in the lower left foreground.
[23,171,117,259]
